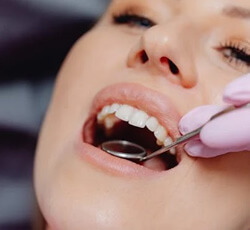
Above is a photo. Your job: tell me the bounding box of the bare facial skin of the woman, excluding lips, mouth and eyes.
[35,0,250,230]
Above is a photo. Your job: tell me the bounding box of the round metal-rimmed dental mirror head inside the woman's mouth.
[101,140,147,160]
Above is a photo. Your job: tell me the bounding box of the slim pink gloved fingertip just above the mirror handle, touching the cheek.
[179,105,227,135]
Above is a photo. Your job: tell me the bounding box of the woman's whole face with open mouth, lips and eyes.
[35,0,250,230]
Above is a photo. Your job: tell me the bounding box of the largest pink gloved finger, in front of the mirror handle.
[200,108,250,151]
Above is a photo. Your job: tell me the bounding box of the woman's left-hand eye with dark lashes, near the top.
[113,12,156,29]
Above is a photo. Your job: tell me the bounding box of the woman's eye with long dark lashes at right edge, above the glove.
[217,41,250,68]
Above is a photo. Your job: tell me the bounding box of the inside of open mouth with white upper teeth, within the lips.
[84,107,178,171]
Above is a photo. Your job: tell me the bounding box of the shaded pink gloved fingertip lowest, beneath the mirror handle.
[184,140,232,158]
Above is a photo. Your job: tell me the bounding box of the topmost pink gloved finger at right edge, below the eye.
[223,73,250,105]
